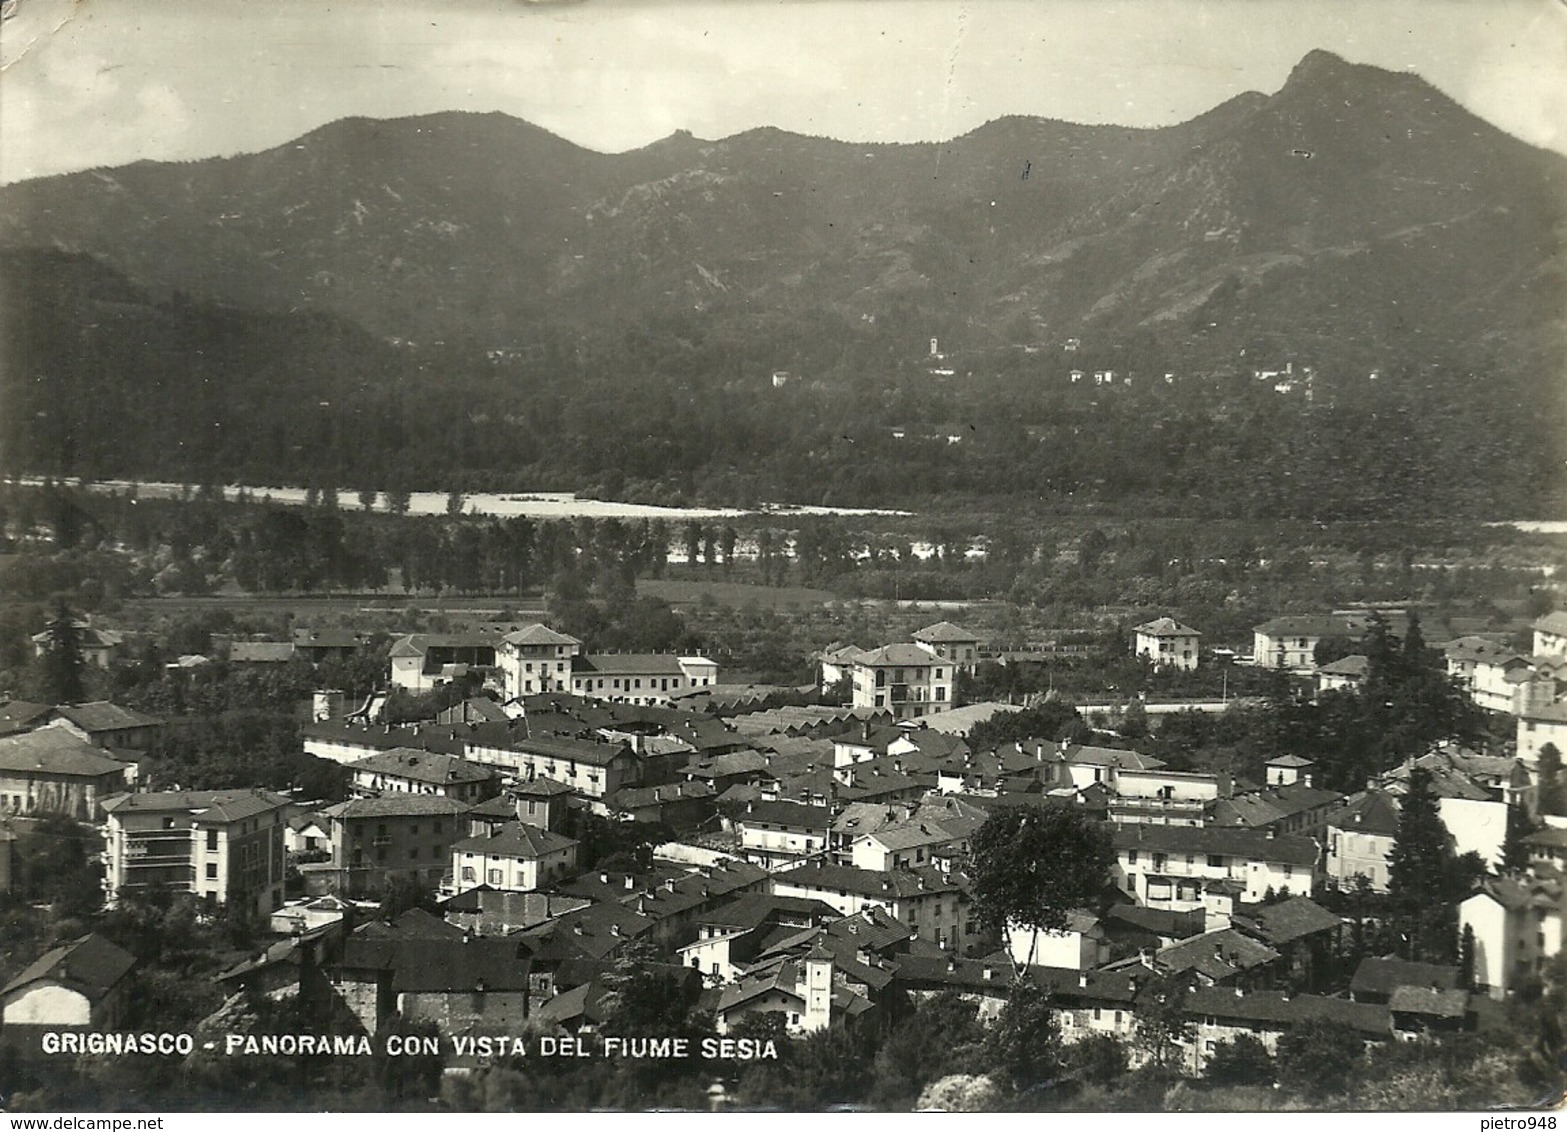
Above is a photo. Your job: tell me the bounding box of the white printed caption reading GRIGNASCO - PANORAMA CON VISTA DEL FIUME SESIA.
[41,1030,779,1061]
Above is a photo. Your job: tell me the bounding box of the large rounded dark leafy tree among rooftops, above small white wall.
[968,806,1114,959]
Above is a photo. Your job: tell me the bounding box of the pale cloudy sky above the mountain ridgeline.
[0,0,1567,183]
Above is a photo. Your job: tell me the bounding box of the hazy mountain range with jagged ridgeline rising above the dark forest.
[0,52,1567,514]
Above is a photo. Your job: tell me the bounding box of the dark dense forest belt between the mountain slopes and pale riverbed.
[0,251,1567,521]
